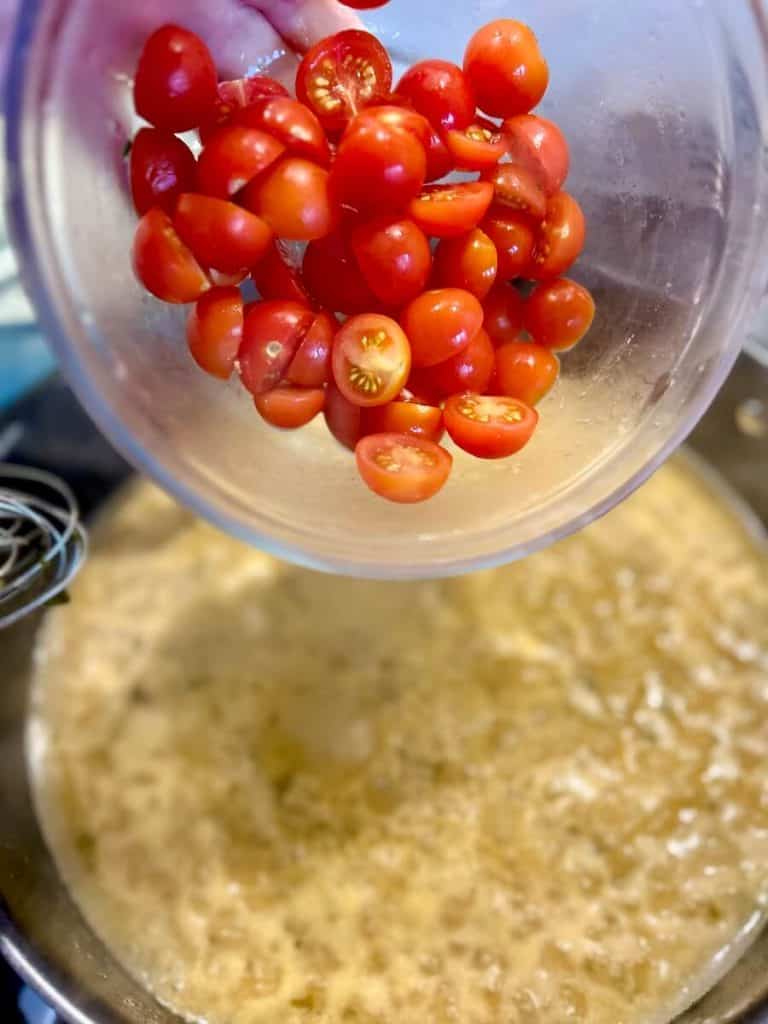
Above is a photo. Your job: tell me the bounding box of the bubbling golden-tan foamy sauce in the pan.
[33,462,768,1024]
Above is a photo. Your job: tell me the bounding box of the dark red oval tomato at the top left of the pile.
[133,25,216,132]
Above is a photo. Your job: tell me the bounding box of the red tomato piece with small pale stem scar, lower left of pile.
[238,299,314,395]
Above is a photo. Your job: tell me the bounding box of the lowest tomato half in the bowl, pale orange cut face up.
[354,434,454,504]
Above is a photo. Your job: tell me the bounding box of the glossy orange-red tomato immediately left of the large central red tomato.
[242,157,339,242]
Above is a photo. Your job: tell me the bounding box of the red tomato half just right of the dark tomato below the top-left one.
[198,124,286,199]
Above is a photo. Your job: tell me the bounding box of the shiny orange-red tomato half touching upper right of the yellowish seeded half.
[401,288,482,369]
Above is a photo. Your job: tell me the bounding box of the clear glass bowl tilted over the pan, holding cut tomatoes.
[7,0,768,578]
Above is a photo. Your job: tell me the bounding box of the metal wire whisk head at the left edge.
[0,462,88,629]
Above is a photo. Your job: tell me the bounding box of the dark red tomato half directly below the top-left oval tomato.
[131,128,197,216]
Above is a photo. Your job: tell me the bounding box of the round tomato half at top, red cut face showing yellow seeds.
[296,29,392,132]
